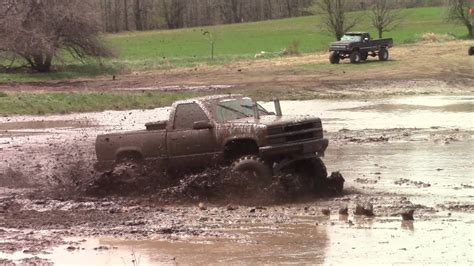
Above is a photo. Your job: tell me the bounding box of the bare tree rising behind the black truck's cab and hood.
[316,0,359,40]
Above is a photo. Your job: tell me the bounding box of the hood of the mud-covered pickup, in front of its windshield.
[227,115,320,126]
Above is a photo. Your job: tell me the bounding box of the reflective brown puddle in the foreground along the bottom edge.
[0,210,474,265]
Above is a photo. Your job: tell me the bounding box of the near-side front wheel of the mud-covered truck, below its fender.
[231,156,272,185]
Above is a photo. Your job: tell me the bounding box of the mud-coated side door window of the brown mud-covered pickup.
[174,103,209,129]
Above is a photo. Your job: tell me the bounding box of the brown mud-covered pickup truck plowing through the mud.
[95,95,334,191]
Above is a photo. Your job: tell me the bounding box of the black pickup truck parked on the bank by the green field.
[329,32,393,64]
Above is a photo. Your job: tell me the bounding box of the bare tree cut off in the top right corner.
[447,0,474,39]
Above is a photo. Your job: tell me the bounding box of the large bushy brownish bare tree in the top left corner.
[0,0,112,72]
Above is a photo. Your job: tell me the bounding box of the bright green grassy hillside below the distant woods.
[107,8,467,61]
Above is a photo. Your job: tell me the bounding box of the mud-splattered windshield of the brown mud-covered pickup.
[216,98,269,122]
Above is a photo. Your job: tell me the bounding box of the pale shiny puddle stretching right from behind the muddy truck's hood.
[264,96,474,132]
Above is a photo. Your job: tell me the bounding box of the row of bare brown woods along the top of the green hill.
[100,0,445,32]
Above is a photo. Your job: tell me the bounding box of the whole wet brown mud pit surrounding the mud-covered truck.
[0,95,474,265]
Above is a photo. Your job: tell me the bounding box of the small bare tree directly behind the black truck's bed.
[370,0,402,38]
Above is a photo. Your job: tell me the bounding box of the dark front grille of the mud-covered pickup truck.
[267,121,323,145]
